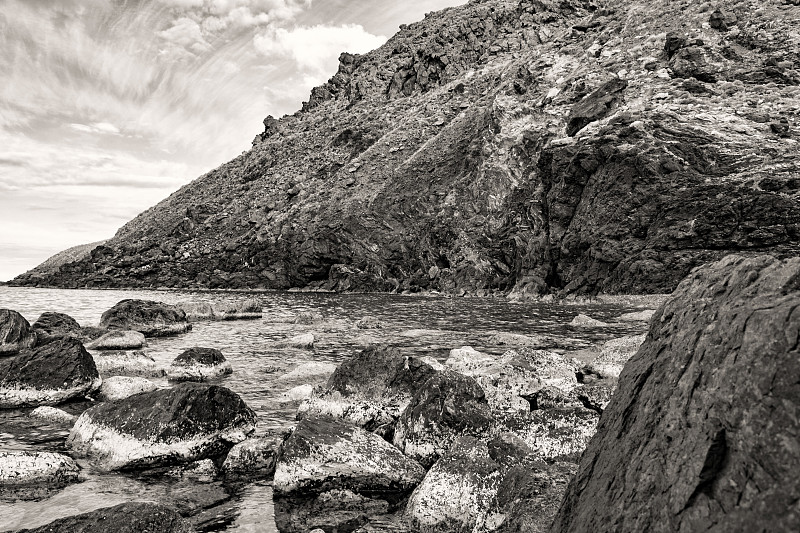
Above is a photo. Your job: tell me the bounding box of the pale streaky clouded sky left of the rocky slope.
[0,0,465,280]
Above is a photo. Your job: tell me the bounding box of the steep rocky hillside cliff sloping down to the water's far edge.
[14,0,800,296]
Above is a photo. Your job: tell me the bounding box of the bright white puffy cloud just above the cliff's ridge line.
[253,24,386,84]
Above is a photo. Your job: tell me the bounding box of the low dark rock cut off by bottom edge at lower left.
[20,502,194,533]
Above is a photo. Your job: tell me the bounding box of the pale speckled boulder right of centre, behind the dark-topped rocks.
[445,346,577,412]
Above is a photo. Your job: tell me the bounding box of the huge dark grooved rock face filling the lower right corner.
[552,256,800,533]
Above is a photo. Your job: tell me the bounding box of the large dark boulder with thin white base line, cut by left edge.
[0,337,102,408]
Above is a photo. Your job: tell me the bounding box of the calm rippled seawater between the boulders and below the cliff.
[0,287,642,532]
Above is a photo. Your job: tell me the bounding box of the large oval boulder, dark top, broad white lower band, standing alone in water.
[67,383,256,470]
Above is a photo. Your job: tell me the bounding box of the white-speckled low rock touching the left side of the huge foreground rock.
[492,407,600,462]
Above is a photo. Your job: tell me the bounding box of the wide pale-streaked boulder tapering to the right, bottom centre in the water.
[274,417,425,505]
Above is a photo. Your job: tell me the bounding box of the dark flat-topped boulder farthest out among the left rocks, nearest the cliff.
[100,300,192,337]
